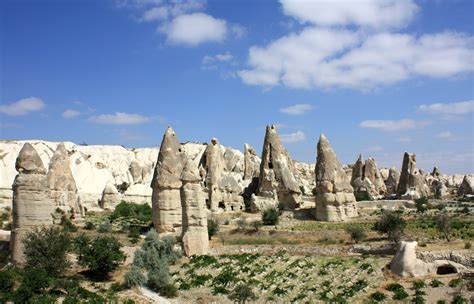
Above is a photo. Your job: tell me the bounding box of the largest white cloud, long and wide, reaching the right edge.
[239,27,474,90]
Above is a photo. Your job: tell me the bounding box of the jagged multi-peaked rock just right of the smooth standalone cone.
[351,155,387,200]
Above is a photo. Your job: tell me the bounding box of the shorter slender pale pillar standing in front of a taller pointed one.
[181,160,209,256]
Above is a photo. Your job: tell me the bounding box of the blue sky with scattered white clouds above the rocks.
[0,0,474,174]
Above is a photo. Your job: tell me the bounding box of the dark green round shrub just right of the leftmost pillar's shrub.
[74,235,125,278]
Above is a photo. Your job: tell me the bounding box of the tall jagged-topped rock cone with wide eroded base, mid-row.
[257,125,301,209]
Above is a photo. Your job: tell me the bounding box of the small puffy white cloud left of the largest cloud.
[162,13,227,46]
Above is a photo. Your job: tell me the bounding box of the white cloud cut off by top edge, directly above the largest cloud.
[280,0,418,28]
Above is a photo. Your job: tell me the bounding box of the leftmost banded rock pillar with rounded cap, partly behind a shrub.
[10,143,53,264]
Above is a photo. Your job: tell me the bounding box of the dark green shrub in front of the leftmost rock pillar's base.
[23,227,71,277]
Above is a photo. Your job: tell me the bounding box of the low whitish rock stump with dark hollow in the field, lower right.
[390,241,465,277]
